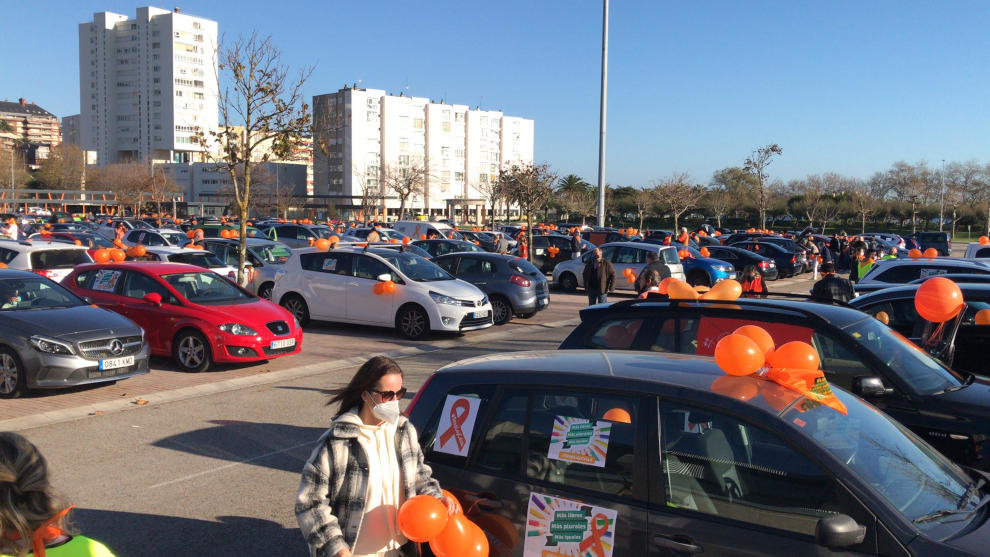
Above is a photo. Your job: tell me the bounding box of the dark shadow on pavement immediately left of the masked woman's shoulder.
[152,420,329,474]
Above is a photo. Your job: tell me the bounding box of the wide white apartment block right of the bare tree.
[313,87,533,218]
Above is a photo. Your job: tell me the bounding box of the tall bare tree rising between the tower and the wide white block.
[195,32,312,285]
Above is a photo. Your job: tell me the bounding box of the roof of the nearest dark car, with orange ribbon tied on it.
[436,350,808,415]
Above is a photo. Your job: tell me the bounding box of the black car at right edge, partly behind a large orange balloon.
[849,282,990,375]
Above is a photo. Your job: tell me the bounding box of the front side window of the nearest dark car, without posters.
[660,401,840,536]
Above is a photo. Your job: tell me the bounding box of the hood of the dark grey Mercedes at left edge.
[3,305,141,342]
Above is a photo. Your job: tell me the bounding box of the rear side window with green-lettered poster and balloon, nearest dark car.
[526,389,639,496]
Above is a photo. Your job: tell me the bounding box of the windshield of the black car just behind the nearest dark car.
[843,317,964,395]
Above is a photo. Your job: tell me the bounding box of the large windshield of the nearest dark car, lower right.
[781,384,981,539]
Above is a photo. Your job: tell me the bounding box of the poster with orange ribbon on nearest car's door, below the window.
[523,491,618,557]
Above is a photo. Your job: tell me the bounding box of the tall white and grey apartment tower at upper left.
[79,7,218,165]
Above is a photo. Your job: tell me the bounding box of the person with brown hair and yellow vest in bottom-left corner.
[0,432,113,557]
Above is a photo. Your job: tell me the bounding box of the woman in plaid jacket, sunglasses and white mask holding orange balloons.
[295,356,456,557]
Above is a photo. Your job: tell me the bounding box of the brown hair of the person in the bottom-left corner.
[0,432,61,556]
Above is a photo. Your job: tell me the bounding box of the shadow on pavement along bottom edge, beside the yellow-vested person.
[69,508,307,555]
